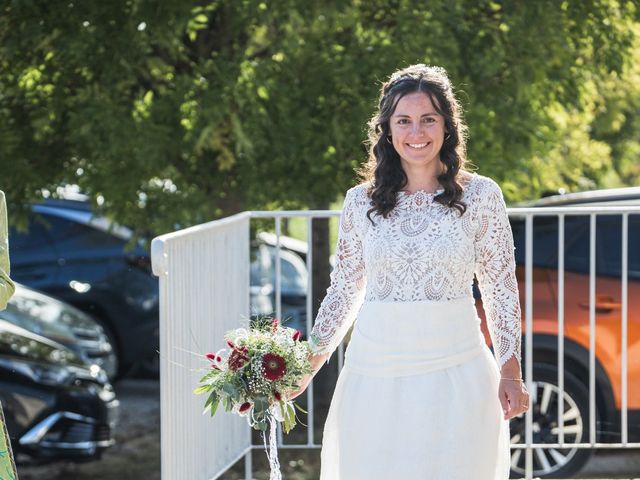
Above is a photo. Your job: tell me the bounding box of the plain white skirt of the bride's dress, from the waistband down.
[320,297,510,480]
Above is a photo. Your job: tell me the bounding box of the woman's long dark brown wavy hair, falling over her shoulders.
[358,63,467,223]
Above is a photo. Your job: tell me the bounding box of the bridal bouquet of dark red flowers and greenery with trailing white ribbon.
[194,317,313,480]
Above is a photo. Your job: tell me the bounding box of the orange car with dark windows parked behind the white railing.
[475,187,640,478]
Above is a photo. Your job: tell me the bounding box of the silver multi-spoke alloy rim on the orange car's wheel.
[510,381,584,476]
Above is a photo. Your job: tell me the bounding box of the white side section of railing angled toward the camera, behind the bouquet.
[151,213,252,480]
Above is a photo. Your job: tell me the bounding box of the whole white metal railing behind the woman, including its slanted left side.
[152,207,640,479]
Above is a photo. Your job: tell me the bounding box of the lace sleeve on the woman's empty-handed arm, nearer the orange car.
[475,179,521,368]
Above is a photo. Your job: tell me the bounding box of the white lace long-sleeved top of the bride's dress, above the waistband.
[309,174,521,367]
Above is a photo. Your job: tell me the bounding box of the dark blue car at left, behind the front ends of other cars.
[9,196,159,376]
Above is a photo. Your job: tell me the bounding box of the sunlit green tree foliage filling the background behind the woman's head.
[0,0,640,235]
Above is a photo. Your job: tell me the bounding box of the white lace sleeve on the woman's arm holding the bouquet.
[309,187,366,363]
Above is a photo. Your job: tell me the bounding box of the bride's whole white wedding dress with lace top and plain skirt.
[309,174,521,480]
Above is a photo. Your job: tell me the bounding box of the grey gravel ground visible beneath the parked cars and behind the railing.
[12,379,640,480]
